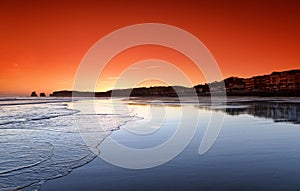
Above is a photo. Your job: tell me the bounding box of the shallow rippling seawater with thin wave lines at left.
[0,98,138,191]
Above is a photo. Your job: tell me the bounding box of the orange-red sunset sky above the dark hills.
[0,0,300,96]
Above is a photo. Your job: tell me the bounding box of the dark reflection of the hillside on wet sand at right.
[216,102,300,124]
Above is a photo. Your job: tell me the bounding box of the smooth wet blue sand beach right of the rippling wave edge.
[42,97,300,191]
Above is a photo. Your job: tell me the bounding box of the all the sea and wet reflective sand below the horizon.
[0,97,300,191]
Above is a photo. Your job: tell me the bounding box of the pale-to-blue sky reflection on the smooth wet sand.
[42,100,300,191]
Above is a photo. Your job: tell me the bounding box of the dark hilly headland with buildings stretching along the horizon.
[50,69,300,97]
